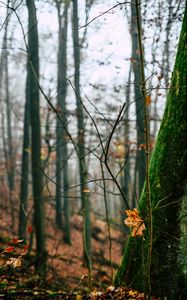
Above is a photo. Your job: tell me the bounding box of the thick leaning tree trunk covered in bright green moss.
[114,2,187,299]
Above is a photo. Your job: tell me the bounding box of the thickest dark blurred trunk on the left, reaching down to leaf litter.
[26,0,47,276]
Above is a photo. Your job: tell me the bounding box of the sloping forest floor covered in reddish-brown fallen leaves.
[0,200,160,300]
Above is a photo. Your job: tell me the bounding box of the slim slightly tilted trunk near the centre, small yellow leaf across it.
[73,0,91,270]
